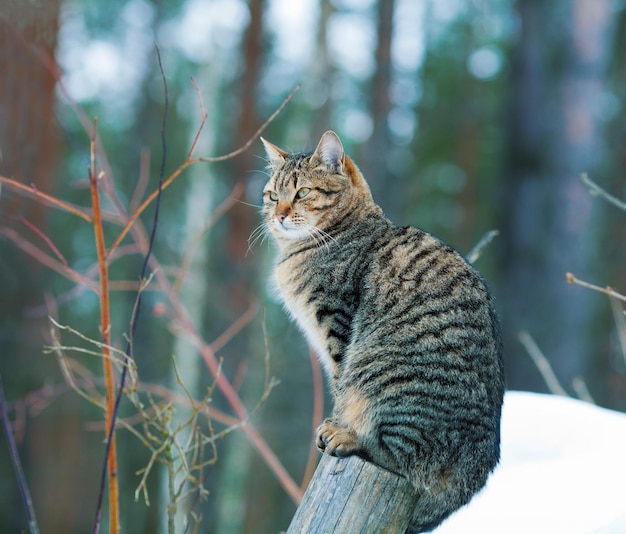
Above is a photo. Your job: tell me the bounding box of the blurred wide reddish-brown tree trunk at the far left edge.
[0,0,69,532]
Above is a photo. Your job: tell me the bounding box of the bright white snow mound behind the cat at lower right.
[433,391,626,534]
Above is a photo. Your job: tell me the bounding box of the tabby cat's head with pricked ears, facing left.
[261,131,373,248]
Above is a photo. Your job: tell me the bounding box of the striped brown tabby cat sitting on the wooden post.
[262,131,504,532]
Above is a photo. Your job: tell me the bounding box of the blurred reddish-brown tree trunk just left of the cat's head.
[212,0,267,534]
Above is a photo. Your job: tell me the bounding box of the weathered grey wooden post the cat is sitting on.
[287,454,417,534]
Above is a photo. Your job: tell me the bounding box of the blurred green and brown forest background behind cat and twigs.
[0,0,626,534]
